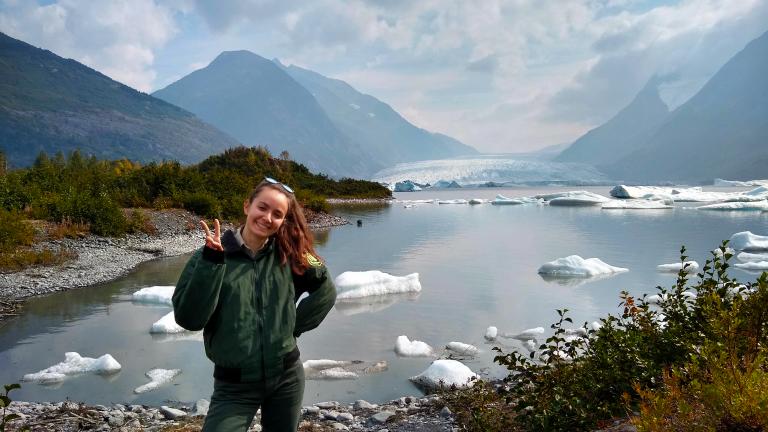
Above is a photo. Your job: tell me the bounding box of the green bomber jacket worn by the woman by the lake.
[173,230,336,381]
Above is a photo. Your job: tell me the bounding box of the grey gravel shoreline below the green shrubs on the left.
[0,209,349,302]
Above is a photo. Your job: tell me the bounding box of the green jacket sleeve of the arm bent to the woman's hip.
[293,263,336,337]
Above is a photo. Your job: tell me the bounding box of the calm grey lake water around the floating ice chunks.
[0,187,768,404]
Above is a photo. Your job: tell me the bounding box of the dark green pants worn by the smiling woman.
[203,361,304,432]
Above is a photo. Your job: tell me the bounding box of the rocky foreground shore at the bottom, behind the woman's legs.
[1,395,458,432]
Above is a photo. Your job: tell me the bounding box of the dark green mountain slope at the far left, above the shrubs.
[0,33,238,166]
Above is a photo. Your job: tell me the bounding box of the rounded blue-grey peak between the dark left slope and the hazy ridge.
[153,51,381,177]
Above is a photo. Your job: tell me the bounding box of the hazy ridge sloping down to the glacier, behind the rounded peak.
[275,60,477,167]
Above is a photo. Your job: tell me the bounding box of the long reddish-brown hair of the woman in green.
[248,181,322,275]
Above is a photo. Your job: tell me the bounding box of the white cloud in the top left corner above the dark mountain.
[0,0,177,91]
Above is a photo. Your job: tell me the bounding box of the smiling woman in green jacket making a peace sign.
[173,177,336,432]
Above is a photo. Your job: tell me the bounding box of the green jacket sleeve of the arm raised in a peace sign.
[173,247,226,331]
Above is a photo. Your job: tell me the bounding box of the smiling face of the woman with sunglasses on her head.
[243,188,289,239]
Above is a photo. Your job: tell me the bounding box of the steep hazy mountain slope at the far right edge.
[604,32,768,182]
